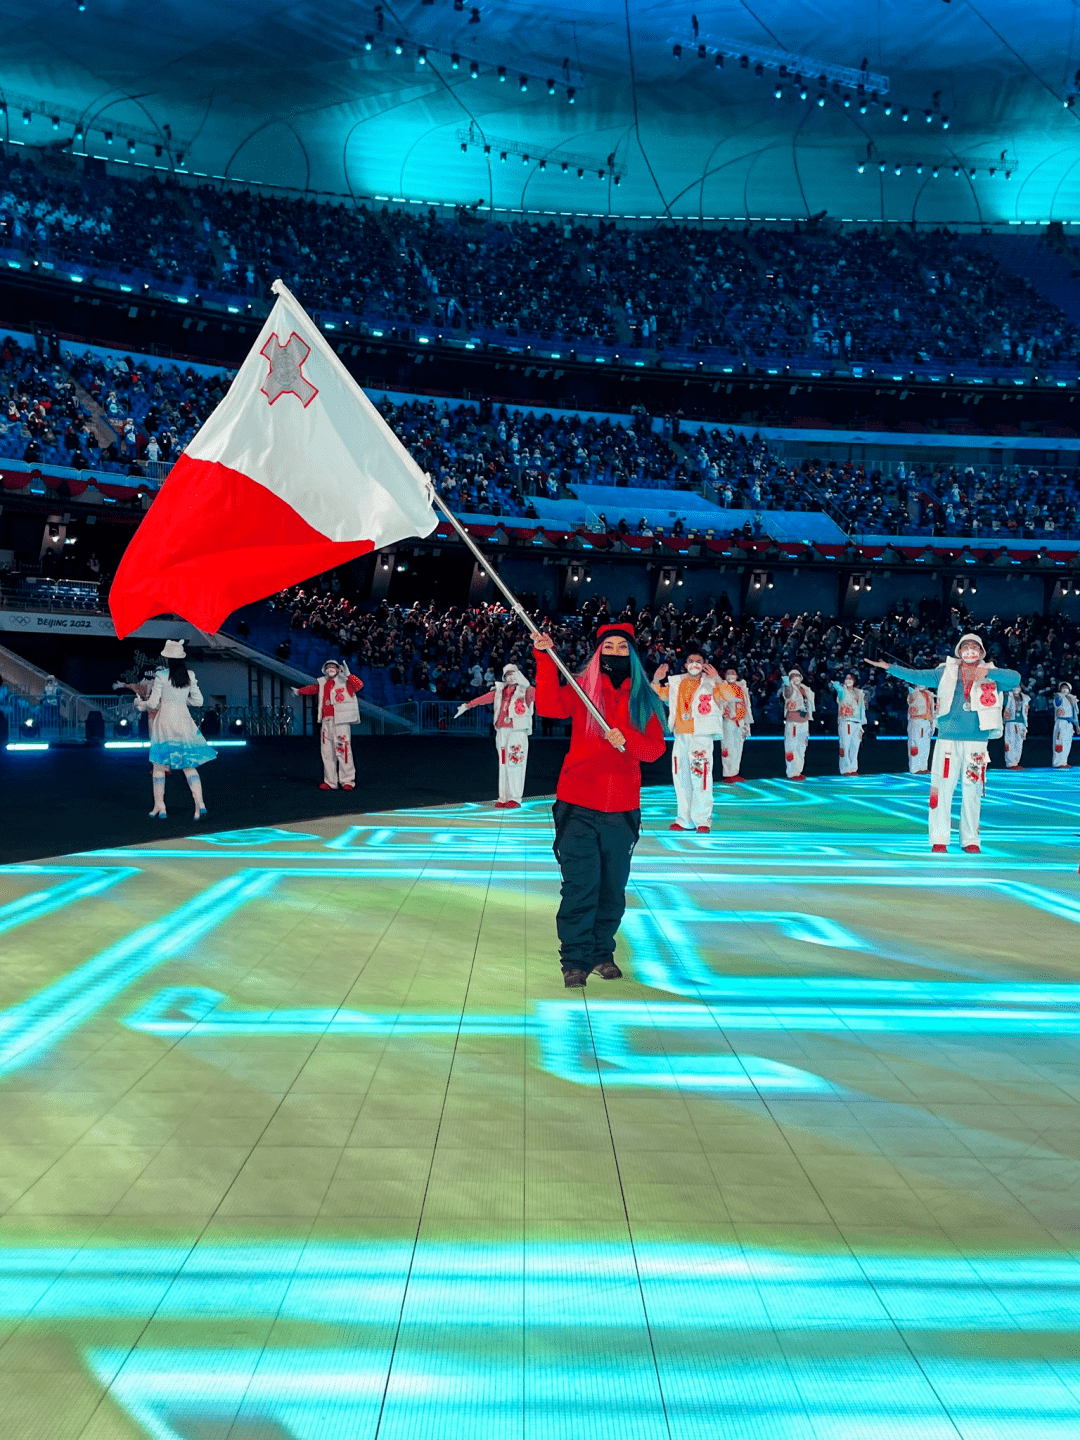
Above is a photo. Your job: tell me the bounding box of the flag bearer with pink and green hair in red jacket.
[533,625,664,986]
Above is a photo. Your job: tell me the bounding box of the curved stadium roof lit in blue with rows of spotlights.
[8,0,1080,225]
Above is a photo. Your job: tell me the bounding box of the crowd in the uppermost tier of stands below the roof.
[0,150,1080,372]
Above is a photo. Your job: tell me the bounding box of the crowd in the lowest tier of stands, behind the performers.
[264,585,1080,724]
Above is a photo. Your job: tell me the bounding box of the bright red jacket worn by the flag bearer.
[536,651,664,814]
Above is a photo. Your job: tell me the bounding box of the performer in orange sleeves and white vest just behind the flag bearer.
[652,651,724,835]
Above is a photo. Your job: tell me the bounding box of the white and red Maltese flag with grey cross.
[109,281,438,638]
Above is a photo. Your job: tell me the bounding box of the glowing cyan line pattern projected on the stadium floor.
[0,773,1080,1440]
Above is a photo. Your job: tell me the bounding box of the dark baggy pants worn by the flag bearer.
[552,801,641,972]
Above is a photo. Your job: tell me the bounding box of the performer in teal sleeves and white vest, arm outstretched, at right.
[867,635,1020,855]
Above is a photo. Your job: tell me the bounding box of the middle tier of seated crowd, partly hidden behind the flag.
[0,324,1080,543]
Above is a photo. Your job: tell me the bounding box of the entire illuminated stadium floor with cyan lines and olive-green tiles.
[0,772,1080,1440]
